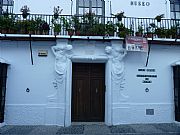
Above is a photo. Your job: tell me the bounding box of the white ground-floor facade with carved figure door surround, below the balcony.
[0,37,177,126]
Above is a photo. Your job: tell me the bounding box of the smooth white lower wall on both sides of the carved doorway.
[0,37,180,125]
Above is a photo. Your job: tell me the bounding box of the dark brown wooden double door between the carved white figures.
[71,63,105,122]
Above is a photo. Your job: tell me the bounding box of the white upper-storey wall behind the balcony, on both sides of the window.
[14,0,170,18]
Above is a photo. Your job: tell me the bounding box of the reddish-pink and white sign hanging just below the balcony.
[126,36,148,52]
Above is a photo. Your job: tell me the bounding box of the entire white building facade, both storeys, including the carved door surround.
[0,0,180,126]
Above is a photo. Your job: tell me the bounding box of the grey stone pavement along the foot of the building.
[0,123,180,135]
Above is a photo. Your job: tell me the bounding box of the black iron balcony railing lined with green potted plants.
[0,14,180,38]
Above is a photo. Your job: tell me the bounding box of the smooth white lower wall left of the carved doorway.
[0,41,55,125]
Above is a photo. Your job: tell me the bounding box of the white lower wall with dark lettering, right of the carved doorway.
[113,45,176,125]
